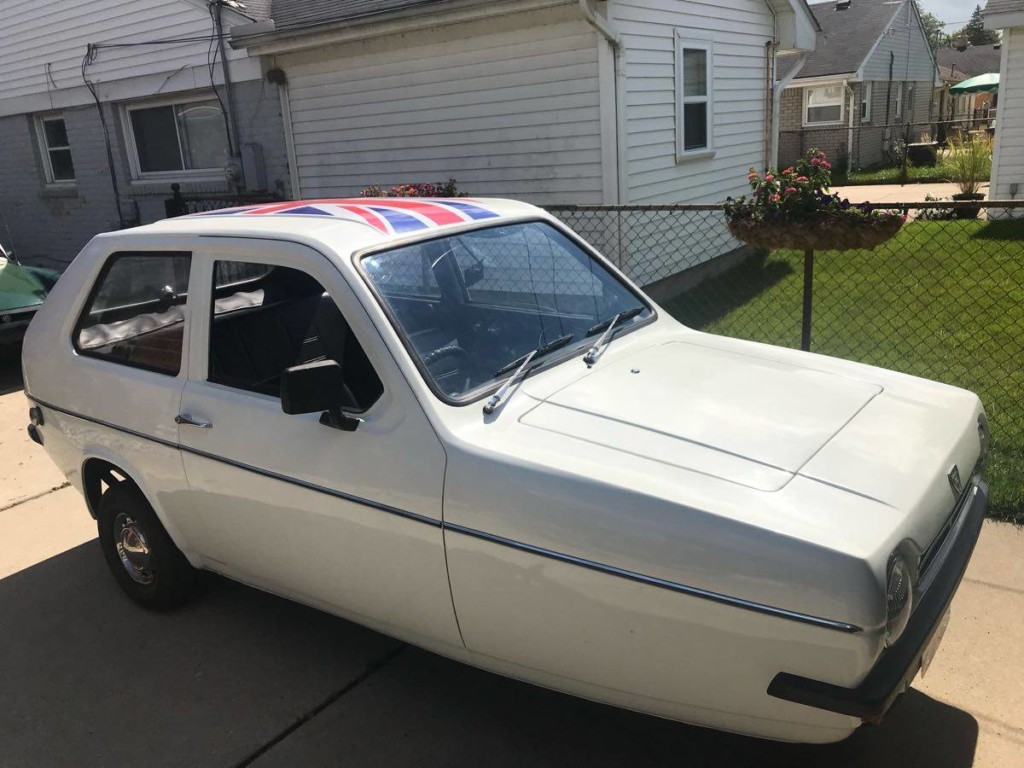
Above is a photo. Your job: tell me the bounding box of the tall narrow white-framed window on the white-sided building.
[676,38,715,158]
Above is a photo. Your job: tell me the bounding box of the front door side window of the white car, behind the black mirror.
[208,261,384,411]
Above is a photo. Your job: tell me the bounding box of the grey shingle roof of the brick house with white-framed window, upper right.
[779,0,902,79]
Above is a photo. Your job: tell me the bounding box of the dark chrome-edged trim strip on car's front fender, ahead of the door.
[444,522,863,634]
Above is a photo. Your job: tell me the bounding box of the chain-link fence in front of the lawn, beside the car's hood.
[548,202,1024,523]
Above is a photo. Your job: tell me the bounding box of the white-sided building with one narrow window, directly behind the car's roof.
[232,0,816,283]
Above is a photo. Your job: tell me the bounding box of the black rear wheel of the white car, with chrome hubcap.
[96,480,196,610]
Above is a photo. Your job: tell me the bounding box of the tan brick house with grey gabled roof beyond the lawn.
[776,0,942,169]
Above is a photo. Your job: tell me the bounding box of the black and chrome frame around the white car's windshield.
[351,216,658,408]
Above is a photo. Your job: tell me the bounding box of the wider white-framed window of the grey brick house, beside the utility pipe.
[127,98,229,176]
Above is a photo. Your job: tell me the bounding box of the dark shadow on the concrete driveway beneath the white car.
[0,541,978,768]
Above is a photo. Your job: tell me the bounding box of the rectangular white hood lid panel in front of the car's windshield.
[521,341,883,490]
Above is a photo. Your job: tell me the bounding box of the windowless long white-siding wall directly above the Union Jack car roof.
[275,6,603,203]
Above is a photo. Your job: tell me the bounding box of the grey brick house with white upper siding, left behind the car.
[0,0,288,268]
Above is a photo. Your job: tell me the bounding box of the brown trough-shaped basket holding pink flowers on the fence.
[728,211,903,251]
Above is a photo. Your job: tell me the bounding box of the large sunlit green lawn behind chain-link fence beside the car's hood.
[665,221,1024,523]
